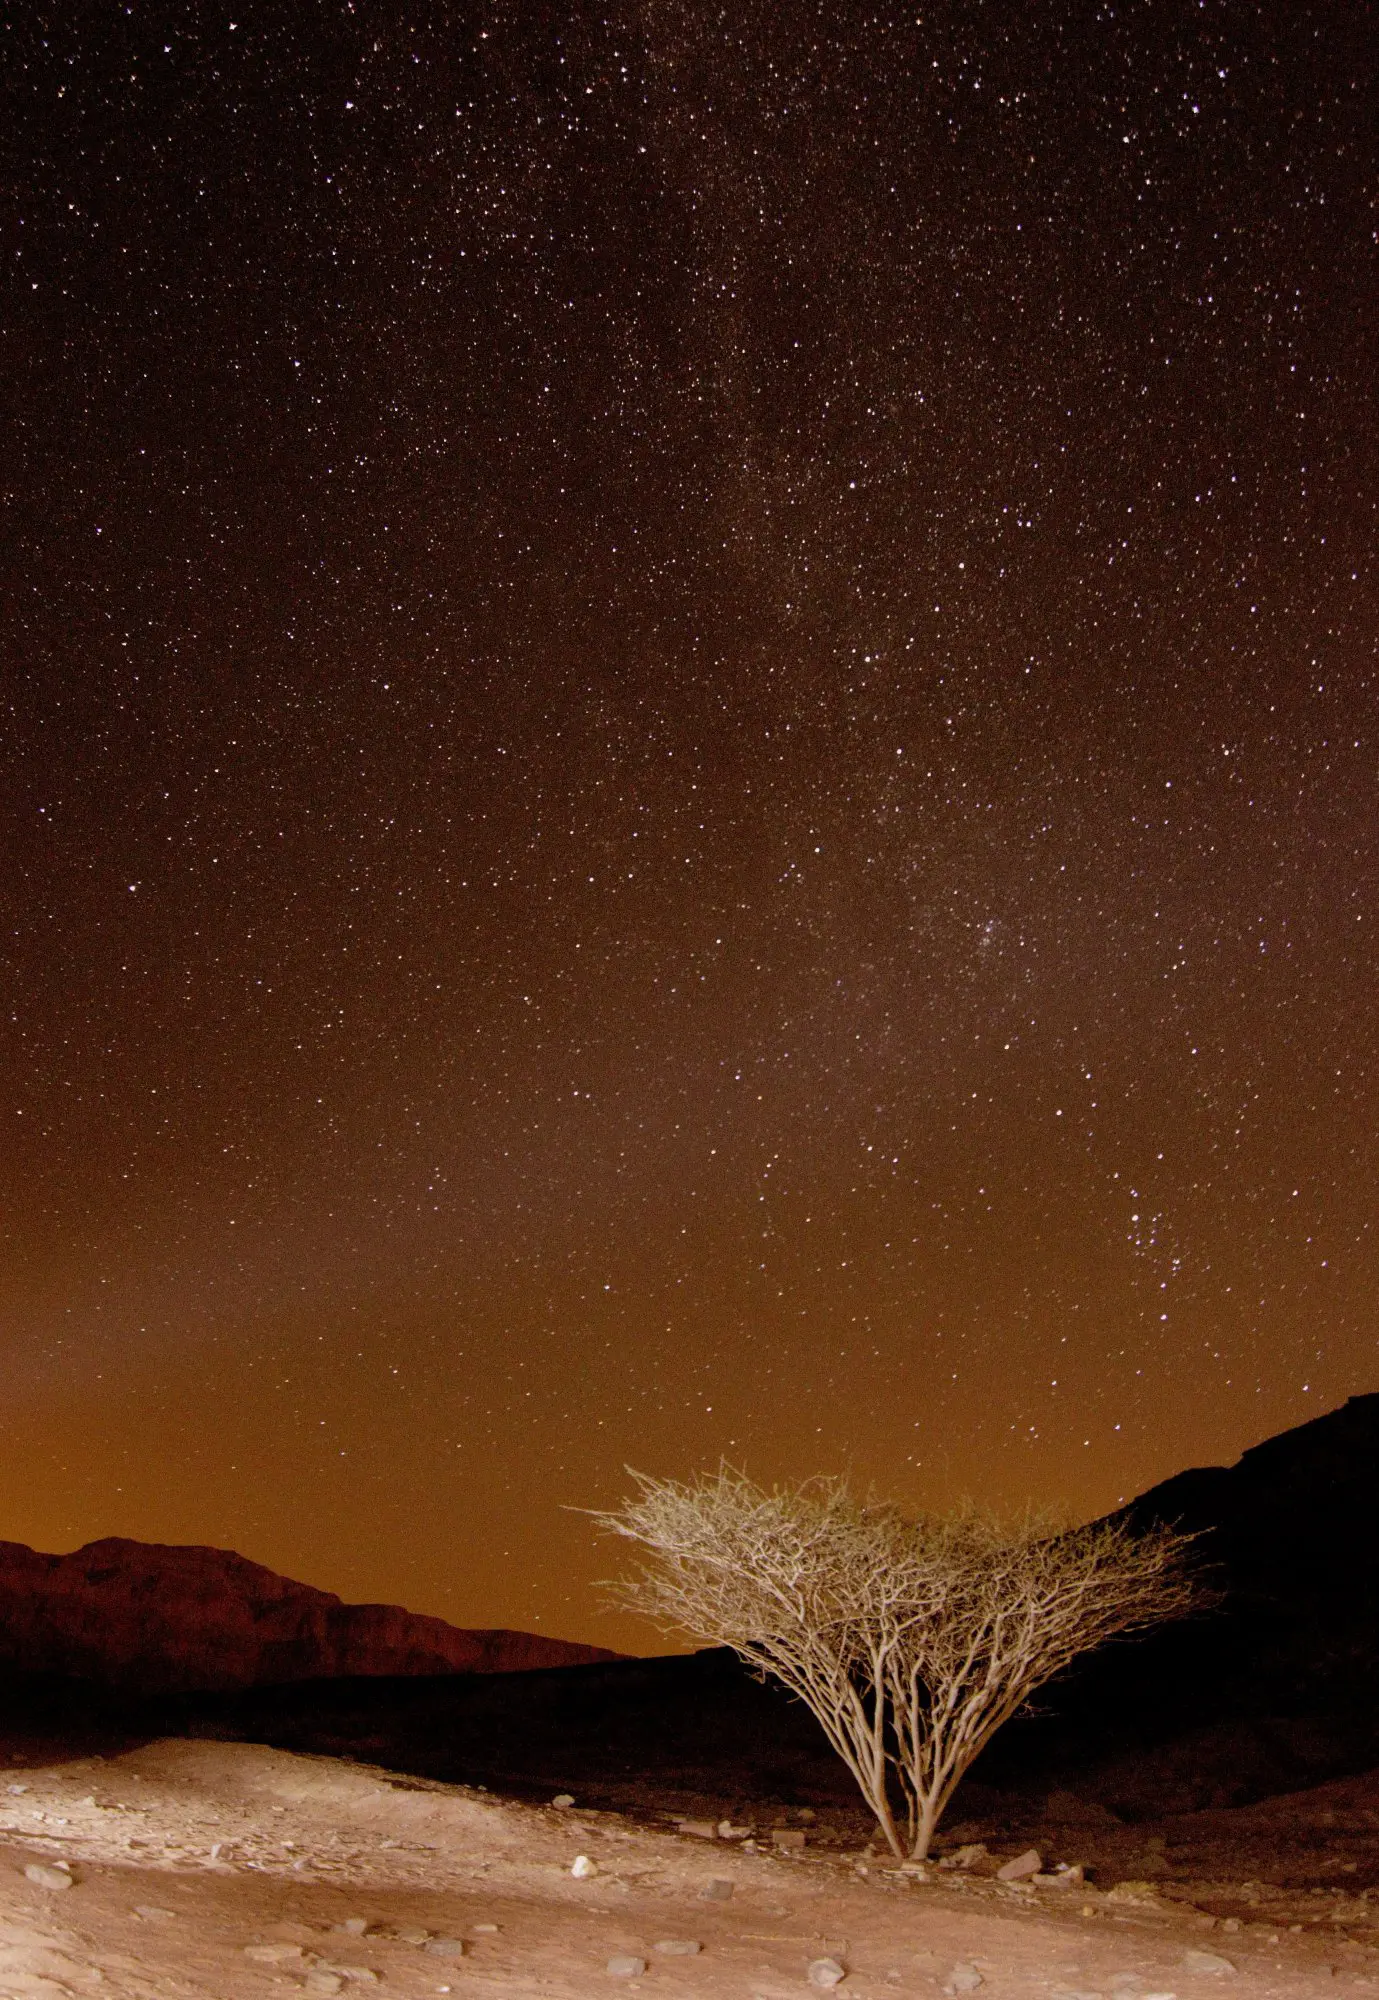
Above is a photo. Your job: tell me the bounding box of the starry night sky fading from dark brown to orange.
[0,0,1379,1648]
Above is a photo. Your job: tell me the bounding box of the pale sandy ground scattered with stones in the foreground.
[0,1740,1379,2000]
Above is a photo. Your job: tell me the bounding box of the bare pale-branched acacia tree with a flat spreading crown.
[596,1466,1197,1858]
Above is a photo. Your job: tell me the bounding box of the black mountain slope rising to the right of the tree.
[967,1396,1379,1804]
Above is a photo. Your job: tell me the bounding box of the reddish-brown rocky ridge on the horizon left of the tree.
[0,1536,618,1694]
